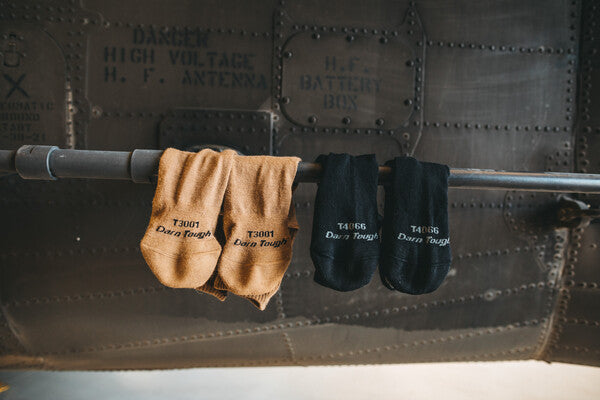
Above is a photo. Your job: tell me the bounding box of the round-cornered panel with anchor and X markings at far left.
[0,23,69,149]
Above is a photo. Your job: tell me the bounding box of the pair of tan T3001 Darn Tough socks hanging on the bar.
[140,149,300,310]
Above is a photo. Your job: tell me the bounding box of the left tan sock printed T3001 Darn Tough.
[140,149,235,288]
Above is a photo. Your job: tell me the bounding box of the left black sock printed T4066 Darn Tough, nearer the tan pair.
[310,153,379,292]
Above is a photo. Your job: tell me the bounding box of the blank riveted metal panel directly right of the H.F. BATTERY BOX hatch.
[424,47,575,127]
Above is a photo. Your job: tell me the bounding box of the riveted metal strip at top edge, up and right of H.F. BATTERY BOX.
[418,0,578,49]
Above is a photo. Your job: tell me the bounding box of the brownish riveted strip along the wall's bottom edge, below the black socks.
[289,324,537,365]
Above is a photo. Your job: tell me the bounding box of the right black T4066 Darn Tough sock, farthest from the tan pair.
[379,157,452,294]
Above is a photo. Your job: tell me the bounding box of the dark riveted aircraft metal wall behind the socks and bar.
[0,0,600,369]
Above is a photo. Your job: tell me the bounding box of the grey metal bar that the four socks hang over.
[0,146,600,193]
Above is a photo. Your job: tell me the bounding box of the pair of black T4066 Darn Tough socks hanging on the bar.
[311,154,451,294]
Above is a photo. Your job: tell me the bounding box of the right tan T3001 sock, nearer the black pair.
[213,156,300,310]
